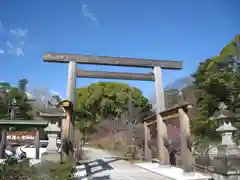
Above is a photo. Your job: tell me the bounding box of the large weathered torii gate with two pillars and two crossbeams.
[43,52,182,163]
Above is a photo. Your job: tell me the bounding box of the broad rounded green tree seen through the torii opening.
[76,82,150,134]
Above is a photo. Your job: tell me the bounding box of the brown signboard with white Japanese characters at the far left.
[7,131,36,141]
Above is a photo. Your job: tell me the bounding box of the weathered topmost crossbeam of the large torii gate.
[43,52,182,70]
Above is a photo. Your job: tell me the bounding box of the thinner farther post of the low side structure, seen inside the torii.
[144,122,152,161]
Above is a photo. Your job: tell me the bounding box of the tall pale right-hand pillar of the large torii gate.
[154,67,168,164]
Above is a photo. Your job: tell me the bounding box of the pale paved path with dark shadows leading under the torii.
[75,148,164,180]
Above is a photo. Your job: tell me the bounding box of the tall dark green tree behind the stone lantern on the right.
[192,36,240,139]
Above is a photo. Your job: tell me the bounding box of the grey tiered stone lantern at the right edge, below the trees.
[211,103,240,180]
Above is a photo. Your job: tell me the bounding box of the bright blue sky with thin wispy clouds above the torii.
[0,0,240,97]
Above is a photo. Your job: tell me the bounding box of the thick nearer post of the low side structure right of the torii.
[178,109,193,172]
